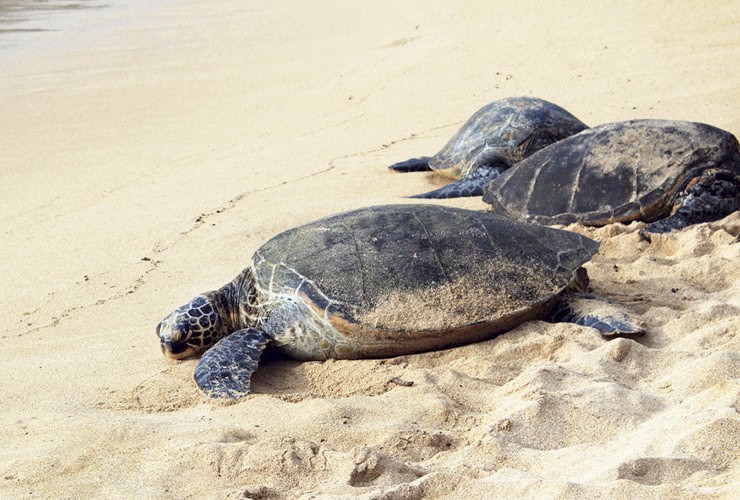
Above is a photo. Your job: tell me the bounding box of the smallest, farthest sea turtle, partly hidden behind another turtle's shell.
[388,97,588,198]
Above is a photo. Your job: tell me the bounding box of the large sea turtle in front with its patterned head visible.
[157,205,644,398]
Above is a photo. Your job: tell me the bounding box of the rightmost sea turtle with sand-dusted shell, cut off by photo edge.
[483,120,740,233]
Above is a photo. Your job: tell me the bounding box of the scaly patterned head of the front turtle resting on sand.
[157,293,228,359]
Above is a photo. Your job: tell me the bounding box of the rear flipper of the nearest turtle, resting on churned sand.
[551,293,645,339]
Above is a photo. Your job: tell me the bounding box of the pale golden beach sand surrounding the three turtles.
[0,0,740,498]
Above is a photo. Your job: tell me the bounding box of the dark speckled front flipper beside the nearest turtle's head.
[195,328,272,399]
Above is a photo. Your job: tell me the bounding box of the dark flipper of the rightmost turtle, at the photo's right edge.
[645,170,740,233]
